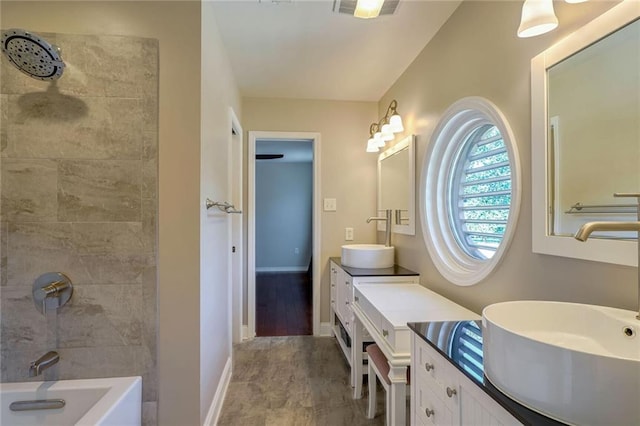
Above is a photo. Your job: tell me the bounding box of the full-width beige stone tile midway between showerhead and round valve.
[58,160,142,222]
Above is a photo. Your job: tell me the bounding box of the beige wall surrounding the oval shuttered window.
[380,1,637,312]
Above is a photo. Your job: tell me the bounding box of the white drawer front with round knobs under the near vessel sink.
[411,333,522,426]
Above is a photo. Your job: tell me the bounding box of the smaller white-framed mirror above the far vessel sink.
[378,135,416,235]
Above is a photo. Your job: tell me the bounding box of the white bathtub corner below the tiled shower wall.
[0,377,142,426]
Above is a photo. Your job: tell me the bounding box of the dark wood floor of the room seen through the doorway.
[256,272,313,336]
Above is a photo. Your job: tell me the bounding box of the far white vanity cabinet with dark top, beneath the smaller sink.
[330,258,420,385]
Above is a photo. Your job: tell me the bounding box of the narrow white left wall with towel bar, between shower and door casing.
[199,1,241,423]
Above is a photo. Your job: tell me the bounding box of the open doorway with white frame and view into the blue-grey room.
[247,132,320,337]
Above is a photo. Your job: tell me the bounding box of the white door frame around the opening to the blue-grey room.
[247,131,322,339]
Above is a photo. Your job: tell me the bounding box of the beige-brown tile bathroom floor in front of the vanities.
[218,336,384,426]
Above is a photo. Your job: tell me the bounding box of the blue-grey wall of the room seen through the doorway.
[255,161,313,271]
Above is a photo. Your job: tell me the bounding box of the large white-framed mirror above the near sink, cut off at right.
[531,0,640,266]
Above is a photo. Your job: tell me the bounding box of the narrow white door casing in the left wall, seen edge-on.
[227,107,246,343]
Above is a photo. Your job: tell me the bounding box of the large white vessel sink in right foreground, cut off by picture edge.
[482,301,640,425]
